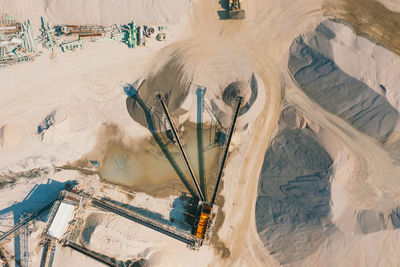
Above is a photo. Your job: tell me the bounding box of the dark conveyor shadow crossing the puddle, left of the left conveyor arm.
[124,85,198,201]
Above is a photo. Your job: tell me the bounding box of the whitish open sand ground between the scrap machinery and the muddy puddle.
[0,26,188,172]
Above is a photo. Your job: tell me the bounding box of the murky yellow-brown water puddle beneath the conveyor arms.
[99,122,221,200]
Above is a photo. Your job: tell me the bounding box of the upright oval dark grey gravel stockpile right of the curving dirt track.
[256,108,334,264]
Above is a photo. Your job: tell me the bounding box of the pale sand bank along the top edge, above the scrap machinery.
[2,0,190,25]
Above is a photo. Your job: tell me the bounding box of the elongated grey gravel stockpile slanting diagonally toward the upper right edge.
[289,21,399,141]
